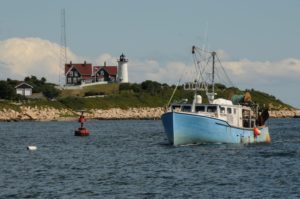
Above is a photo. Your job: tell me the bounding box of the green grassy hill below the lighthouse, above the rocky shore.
[0,80,293,110]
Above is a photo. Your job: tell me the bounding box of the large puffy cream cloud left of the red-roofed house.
[0,38,78,82]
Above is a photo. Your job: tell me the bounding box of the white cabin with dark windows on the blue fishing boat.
[170,99,256,128]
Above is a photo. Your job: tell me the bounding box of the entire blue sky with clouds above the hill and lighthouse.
[0,0,300,107]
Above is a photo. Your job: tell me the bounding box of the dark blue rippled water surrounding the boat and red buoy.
[0,119,300,198]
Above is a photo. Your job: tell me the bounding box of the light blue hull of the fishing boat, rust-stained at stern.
[161,112,270,145]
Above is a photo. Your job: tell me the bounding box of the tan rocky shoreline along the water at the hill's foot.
[0,107,300,121]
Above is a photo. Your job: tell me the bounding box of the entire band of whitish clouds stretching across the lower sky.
[0,38,300,107]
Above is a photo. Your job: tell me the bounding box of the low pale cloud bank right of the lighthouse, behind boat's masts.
[128,54,300,88]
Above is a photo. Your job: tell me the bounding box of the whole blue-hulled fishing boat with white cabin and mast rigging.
[161,46,271,146]
